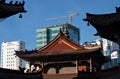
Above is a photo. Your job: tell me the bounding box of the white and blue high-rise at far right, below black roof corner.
[102,38,120,68]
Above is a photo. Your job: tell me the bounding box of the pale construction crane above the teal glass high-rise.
[46,12,79,24]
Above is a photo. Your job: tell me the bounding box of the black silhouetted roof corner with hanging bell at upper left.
[0,0,27,19]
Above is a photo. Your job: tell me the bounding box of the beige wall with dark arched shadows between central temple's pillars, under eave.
[44,63,77,74]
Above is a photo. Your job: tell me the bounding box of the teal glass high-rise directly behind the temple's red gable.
[36,23,80,49]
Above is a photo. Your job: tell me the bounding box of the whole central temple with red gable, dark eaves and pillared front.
[16,26,107,79]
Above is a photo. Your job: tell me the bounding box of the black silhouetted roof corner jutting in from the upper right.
[84,7,120,44]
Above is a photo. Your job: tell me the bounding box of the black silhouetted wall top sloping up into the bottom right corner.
[74,67,120,79]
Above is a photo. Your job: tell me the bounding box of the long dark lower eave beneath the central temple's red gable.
[16,48,105,63]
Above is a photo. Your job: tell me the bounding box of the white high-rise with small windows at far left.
[1,41,26,70]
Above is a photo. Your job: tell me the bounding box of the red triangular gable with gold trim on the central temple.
[38,30,84,52]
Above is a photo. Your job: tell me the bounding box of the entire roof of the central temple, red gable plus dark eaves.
[16,30,104,62]
